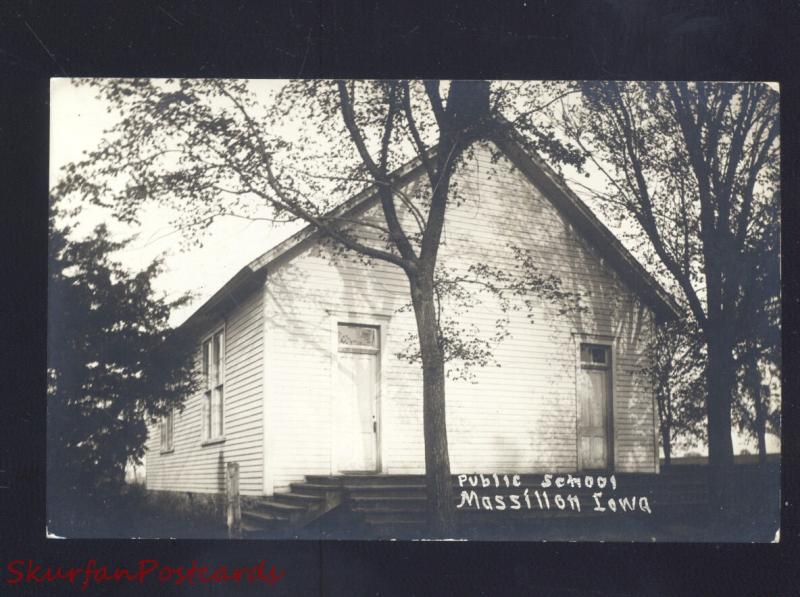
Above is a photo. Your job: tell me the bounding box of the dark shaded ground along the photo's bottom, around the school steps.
[48,459,780,542]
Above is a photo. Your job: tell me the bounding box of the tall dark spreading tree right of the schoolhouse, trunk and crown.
[563,82,779,502]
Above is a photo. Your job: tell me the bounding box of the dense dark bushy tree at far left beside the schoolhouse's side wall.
[47,196,194,524]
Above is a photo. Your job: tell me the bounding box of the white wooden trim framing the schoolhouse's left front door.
[326,309,391,475]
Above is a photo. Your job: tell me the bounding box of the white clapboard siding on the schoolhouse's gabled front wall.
[265,142,655,491]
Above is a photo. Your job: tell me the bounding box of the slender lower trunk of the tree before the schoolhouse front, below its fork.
[411,280,455,537]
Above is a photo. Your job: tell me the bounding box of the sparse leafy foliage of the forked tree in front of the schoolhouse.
[57,79,584,384]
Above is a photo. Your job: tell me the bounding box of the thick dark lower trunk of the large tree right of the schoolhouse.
[706,334,736,510]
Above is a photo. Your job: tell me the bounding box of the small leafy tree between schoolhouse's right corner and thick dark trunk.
[643,321,705,465]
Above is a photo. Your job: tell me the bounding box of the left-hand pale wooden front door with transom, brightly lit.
[334,324,380,471]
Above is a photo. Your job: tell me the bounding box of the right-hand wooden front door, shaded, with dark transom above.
[578,344,611,470]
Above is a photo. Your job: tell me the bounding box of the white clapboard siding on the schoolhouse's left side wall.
[147,289,264,495]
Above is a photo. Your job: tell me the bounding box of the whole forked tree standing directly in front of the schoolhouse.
[54,79,580,534]
